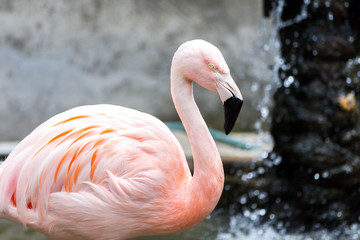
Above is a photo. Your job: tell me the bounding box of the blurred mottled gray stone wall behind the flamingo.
[0,0,273,141]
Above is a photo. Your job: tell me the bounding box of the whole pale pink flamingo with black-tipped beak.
[0,40,242,239]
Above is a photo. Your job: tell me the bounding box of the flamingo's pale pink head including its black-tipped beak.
[172,40,243,134]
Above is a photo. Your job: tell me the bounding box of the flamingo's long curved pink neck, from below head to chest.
[171,68,224,221]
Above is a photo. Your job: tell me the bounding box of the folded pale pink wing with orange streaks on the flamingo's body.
[0,105,191,239]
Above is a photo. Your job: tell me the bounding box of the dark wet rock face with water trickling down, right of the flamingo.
[264,0,360,229]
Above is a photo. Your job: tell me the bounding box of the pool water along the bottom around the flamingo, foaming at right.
[0,212,360,240]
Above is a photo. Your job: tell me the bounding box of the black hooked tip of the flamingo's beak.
[224,96,243,135]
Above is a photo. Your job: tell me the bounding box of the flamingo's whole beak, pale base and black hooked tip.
[217,76,243,135]
